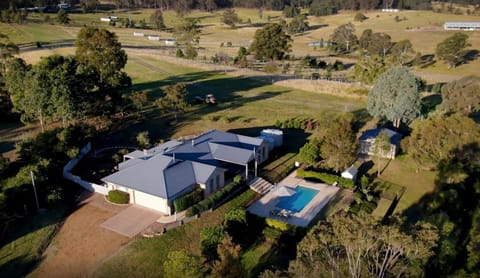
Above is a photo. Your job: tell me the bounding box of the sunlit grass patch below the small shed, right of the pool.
[371,155,436,213]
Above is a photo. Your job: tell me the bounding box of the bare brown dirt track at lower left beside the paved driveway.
[29,194,130,278]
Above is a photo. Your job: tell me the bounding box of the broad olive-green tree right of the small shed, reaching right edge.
[403,115,480,169]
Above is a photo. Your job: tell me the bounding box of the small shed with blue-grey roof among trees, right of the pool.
[359,128,402,159]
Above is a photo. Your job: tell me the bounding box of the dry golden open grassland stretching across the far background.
[4,9,480,82]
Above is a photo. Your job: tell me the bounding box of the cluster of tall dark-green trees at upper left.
[2,28,131,128]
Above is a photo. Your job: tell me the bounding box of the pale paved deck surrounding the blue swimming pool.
[248,171,339,227]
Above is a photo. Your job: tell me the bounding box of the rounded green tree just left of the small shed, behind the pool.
[320,116,358,172]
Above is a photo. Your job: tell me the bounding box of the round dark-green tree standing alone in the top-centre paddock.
[250,23,292,60]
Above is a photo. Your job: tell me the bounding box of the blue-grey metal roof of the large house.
[102,130,264,199]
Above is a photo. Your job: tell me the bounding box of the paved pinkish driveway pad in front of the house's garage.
[101,205,163,237]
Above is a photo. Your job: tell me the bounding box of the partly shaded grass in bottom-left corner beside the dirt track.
[0,207,65,277]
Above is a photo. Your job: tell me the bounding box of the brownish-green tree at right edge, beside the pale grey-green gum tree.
[439,76,480,116]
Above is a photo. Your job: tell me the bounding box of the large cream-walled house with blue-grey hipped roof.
[102,130,269,215]
